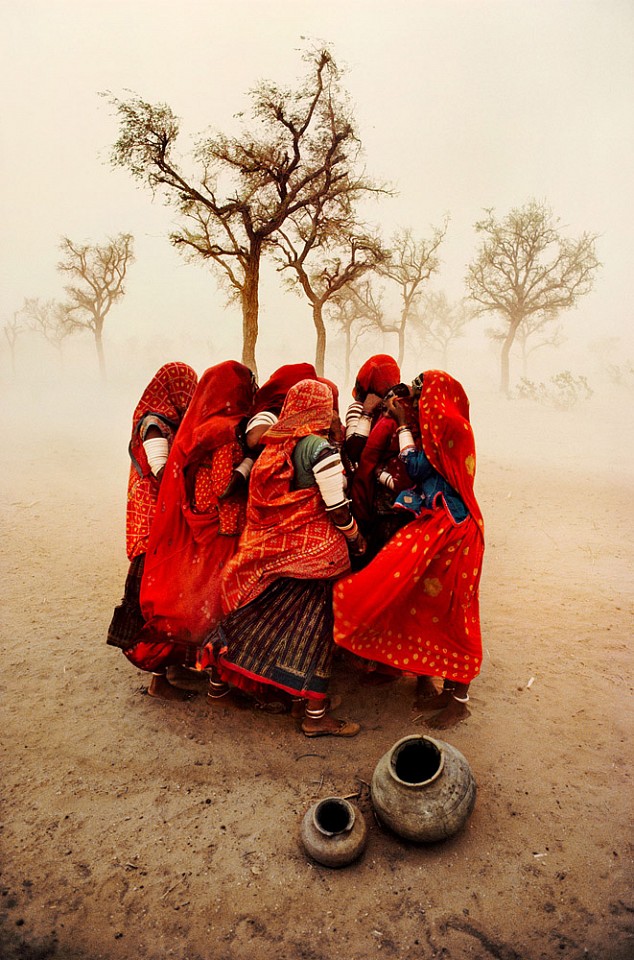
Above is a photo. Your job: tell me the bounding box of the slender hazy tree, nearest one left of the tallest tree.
[57,233,134,381]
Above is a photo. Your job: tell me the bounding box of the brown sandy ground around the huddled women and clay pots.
[0,376,634,960]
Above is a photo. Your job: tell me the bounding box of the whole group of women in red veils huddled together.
[108,354,484,737]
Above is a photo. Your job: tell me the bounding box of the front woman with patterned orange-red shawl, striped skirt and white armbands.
[199,380,363,737]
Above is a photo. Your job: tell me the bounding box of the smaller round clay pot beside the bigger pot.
[301,797,368,867]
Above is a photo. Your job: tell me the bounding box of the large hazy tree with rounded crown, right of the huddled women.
[466,200,600,396]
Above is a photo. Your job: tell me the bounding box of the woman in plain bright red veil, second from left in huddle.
[125,361,255,699]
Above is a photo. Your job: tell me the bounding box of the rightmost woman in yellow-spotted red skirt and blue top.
[334,370,484,729]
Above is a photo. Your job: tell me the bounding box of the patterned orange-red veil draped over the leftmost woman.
[126,362,198,560]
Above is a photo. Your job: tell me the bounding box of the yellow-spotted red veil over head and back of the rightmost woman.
[418,370,483,530]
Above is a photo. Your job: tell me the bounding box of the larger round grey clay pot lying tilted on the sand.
[371,735,476,843]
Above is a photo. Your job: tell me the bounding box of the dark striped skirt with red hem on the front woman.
[205,577,334,698]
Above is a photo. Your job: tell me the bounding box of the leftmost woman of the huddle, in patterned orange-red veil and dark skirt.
[107,362,198,684]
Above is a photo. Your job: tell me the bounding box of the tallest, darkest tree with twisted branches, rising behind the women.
[106,49,376,372]
